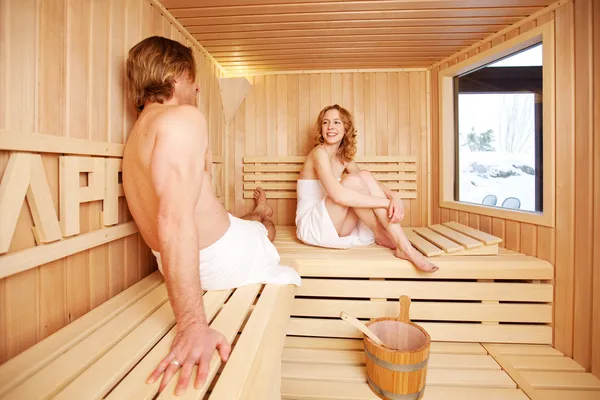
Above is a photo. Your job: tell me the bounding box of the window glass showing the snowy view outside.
[454,43,543,212]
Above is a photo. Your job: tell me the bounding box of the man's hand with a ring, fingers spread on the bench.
[147,324,231,396]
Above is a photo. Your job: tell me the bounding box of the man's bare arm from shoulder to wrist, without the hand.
[151,105,208,328]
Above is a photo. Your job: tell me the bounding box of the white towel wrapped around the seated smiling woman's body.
[296,179,375,249]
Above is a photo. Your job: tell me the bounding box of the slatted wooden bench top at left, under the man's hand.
[0,272,295,400]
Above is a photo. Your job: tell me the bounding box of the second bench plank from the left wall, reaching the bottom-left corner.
[5,285,168,399]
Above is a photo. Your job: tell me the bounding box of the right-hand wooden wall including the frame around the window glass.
[431,0,600,376]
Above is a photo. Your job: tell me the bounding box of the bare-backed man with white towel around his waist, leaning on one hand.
[123,36,300,394]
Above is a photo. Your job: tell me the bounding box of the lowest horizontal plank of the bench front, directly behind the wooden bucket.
[287,317,552,344]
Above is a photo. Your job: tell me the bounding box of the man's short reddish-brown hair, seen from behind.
[127,36,196,111]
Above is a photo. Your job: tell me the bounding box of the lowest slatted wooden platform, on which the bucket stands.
[281,336,600,400]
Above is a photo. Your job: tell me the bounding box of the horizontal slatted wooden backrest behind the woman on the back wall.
[243,156,417,199]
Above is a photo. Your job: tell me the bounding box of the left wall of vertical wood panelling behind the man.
[0,0,223,363]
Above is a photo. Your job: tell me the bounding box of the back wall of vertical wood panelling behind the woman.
[226,70,428,226]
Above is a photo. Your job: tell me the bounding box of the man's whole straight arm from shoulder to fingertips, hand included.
[149,107,229,393]
